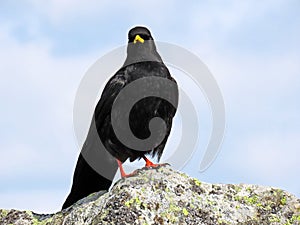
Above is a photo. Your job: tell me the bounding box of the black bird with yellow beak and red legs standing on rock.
[62,26,178,209]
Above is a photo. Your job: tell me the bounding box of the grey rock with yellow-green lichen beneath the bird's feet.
[0,166,300,225]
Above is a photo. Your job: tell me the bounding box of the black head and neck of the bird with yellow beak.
[125,26,162,65]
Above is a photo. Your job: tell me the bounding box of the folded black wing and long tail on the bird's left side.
[63,73,126,209]
